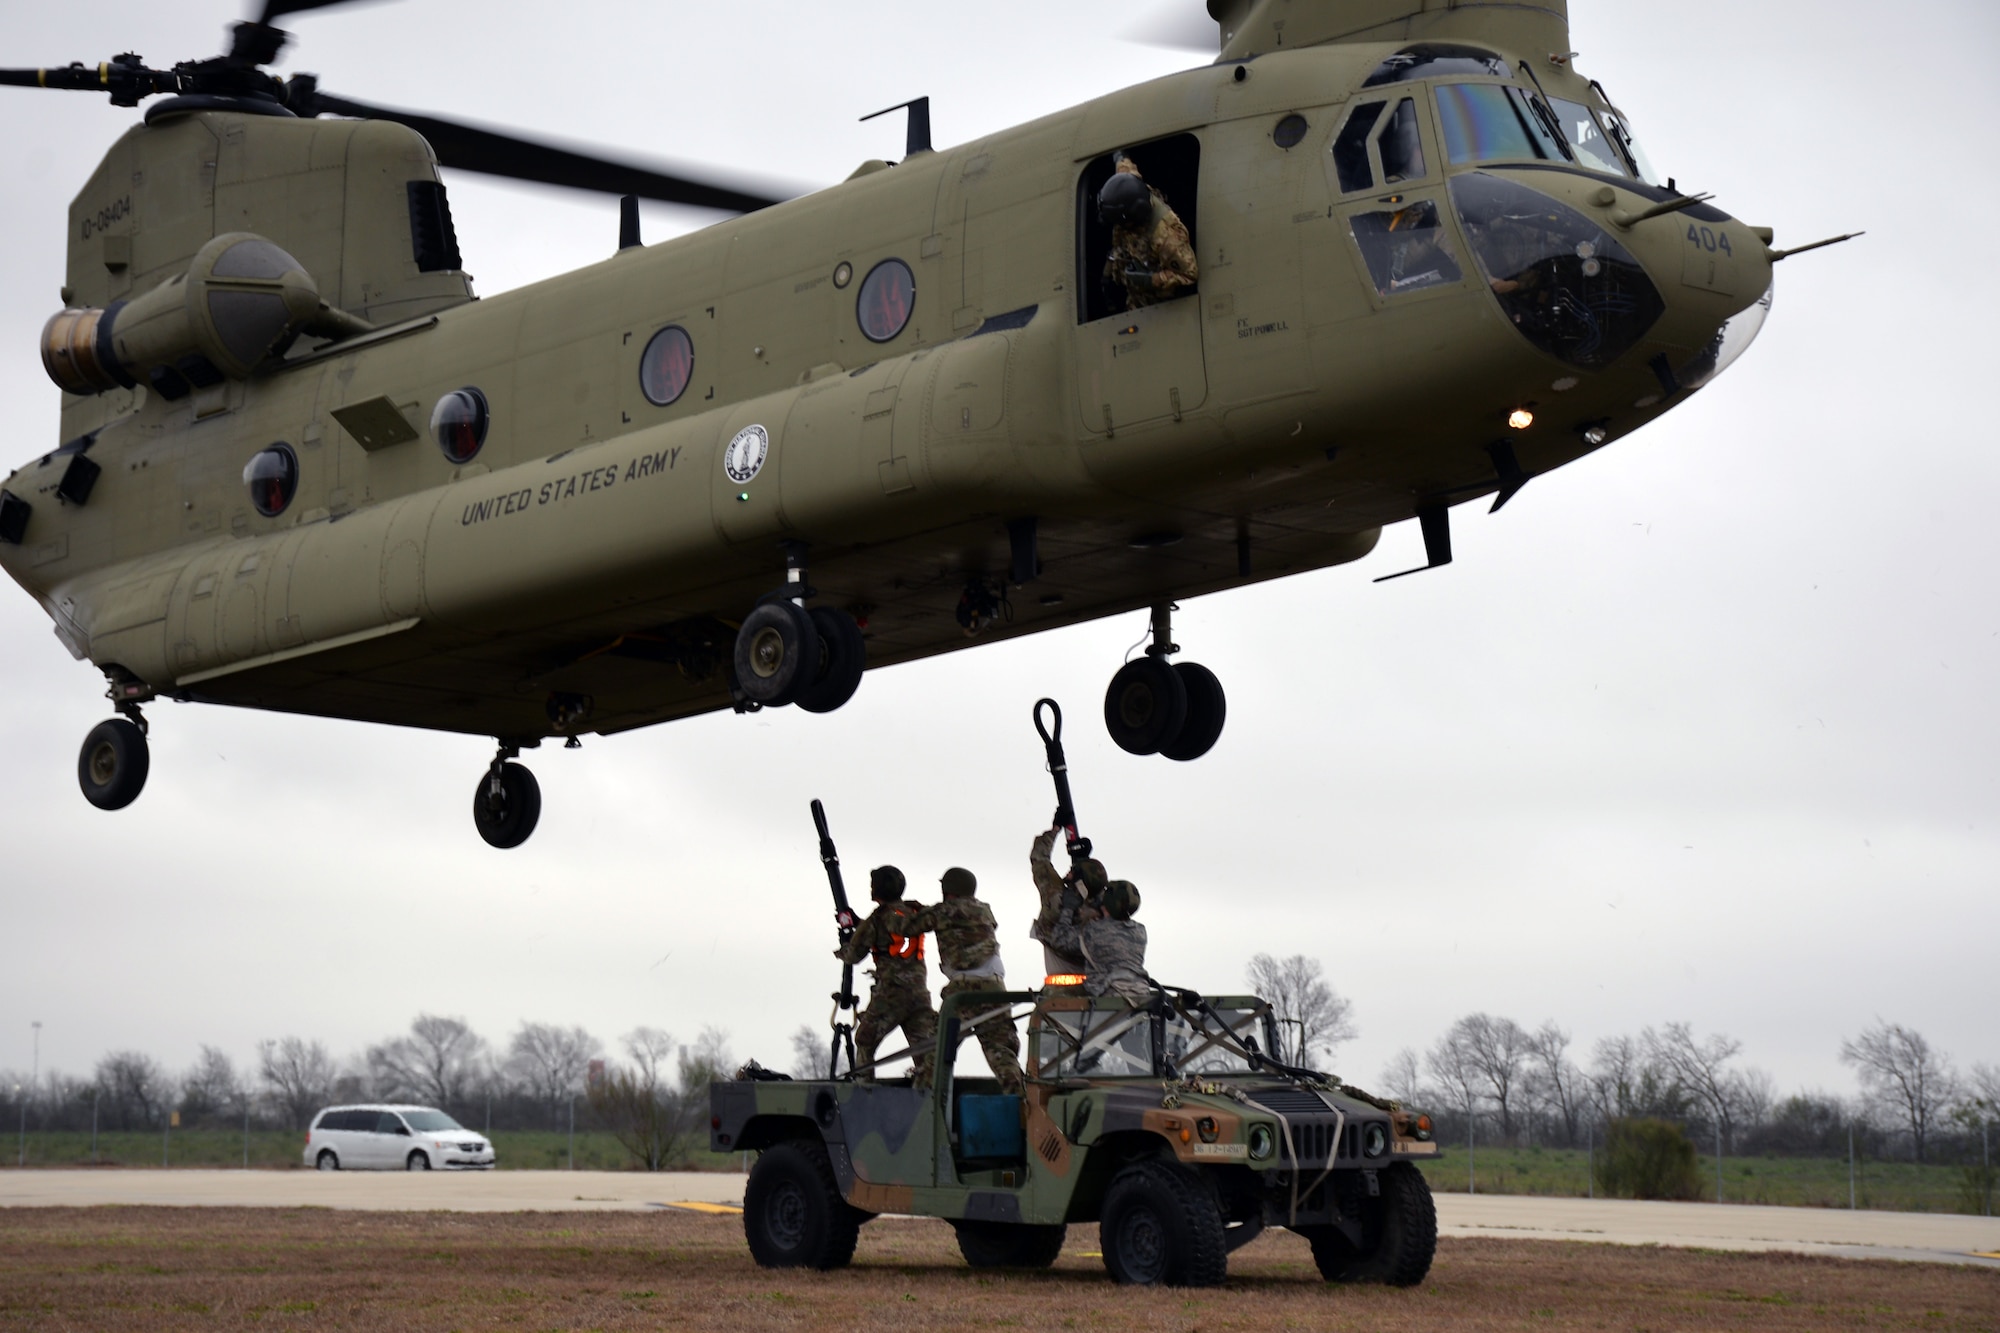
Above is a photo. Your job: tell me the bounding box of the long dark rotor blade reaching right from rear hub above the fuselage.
[286,87,802,212]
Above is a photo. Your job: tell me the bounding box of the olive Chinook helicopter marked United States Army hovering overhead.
[0,0,1826,847]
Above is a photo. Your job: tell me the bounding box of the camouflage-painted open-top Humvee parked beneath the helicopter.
[708,987,1438,1287]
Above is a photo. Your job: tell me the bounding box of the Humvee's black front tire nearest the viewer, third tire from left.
[1098,1161,1230,1287]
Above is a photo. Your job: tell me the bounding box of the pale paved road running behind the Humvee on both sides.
[0,1169,2000,1271]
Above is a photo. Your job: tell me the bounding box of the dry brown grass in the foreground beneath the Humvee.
[0,1209,2000,1333]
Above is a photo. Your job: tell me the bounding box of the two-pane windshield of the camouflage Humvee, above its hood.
[1036,1005,1270,1079]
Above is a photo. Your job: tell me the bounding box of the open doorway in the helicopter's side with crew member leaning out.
[1076,134,1202,324]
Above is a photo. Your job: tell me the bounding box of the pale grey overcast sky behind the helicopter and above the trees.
[0,0,2000,1091]
